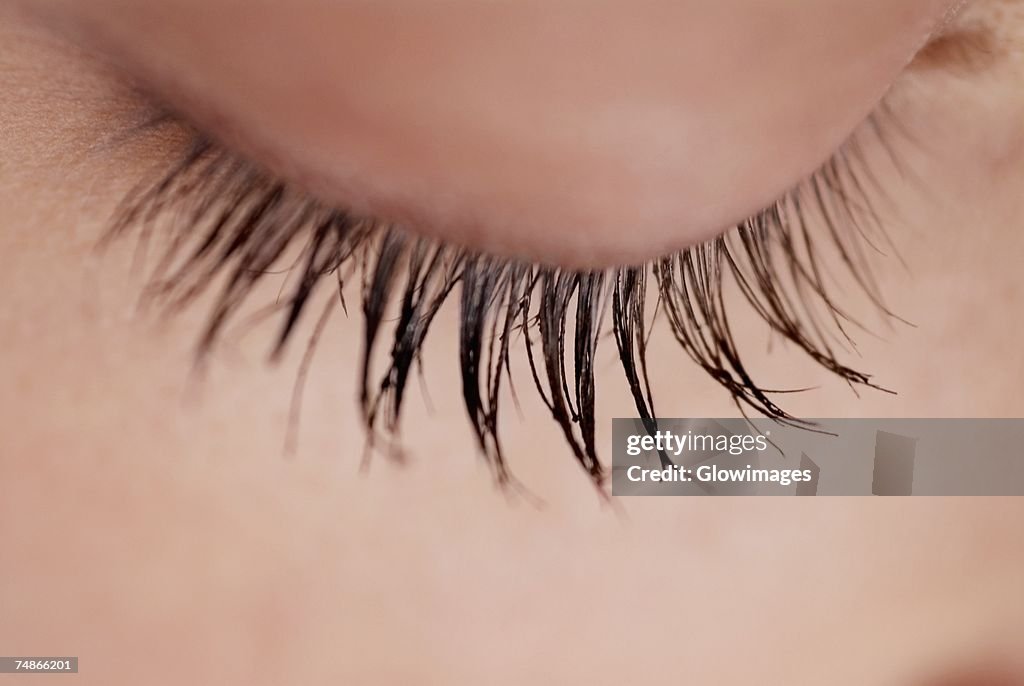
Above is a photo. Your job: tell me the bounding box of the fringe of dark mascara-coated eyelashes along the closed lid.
[110,118,901,483]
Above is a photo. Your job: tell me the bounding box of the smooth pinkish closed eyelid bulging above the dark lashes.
[54,0,948,266]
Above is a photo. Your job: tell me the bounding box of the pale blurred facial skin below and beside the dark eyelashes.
[0,2,1024,686]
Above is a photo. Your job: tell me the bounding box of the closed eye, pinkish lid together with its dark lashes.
[46,2,974,481]
